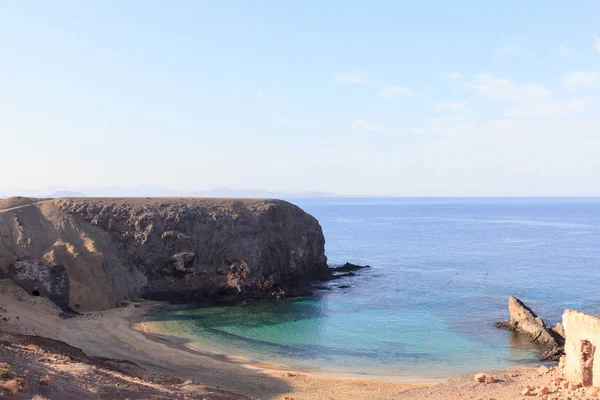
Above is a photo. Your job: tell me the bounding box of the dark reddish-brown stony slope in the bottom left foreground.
[0,333,244,400]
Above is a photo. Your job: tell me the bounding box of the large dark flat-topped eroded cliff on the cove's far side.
[0,199,330,310]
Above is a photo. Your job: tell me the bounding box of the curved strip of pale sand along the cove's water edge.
[62,302,562,400]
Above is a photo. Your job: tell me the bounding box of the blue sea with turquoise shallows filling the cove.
[144,199,600,377]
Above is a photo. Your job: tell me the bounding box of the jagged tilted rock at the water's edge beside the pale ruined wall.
[496,296,565,361]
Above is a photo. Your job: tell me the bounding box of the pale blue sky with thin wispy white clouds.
[0,0,600,196]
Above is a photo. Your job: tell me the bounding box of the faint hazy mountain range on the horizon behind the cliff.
[0,186,344,198]
